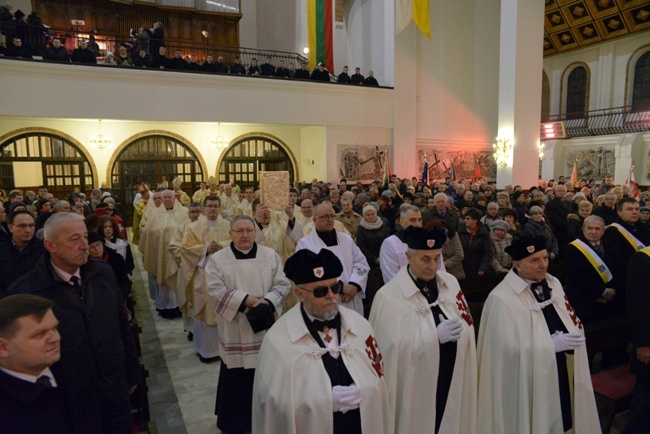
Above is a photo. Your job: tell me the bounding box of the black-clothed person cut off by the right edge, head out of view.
[625,247,650,433]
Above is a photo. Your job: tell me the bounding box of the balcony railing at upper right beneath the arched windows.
[542,106,650,138]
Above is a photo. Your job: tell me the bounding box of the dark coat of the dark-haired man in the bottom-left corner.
[0,362,102,434]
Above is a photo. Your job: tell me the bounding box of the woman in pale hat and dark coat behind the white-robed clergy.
[356,204,390,306]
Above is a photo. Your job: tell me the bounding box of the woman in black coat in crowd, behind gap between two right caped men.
[458,208,494,279]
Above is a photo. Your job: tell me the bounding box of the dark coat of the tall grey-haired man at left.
[7,252,140,430]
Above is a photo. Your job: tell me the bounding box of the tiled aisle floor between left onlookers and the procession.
[133,246,220,434]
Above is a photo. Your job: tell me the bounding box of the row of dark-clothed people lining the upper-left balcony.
[0,3,379,86]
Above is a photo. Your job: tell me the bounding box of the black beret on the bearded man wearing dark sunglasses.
[284,249,343,285]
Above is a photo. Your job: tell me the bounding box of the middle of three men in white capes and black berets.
[370,226,477,434]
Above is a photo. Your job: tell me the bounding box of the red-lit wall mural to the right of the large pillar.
[417,148,497,181]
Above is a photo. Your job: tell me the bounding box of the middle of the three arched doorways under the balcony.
[110,133,204,224]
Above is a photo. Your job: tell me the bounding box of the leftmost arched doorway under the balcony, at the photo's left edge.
[0,129,95,199]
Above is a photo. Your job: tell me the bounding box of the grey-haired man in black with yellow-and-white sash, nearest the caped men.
[564,216,612,324]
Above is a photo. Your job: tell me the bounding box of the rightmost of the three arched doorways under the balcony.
[219,134,297,188]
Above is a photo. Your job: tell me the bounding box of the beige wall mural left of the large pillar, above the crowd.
[337,145,388,183]
